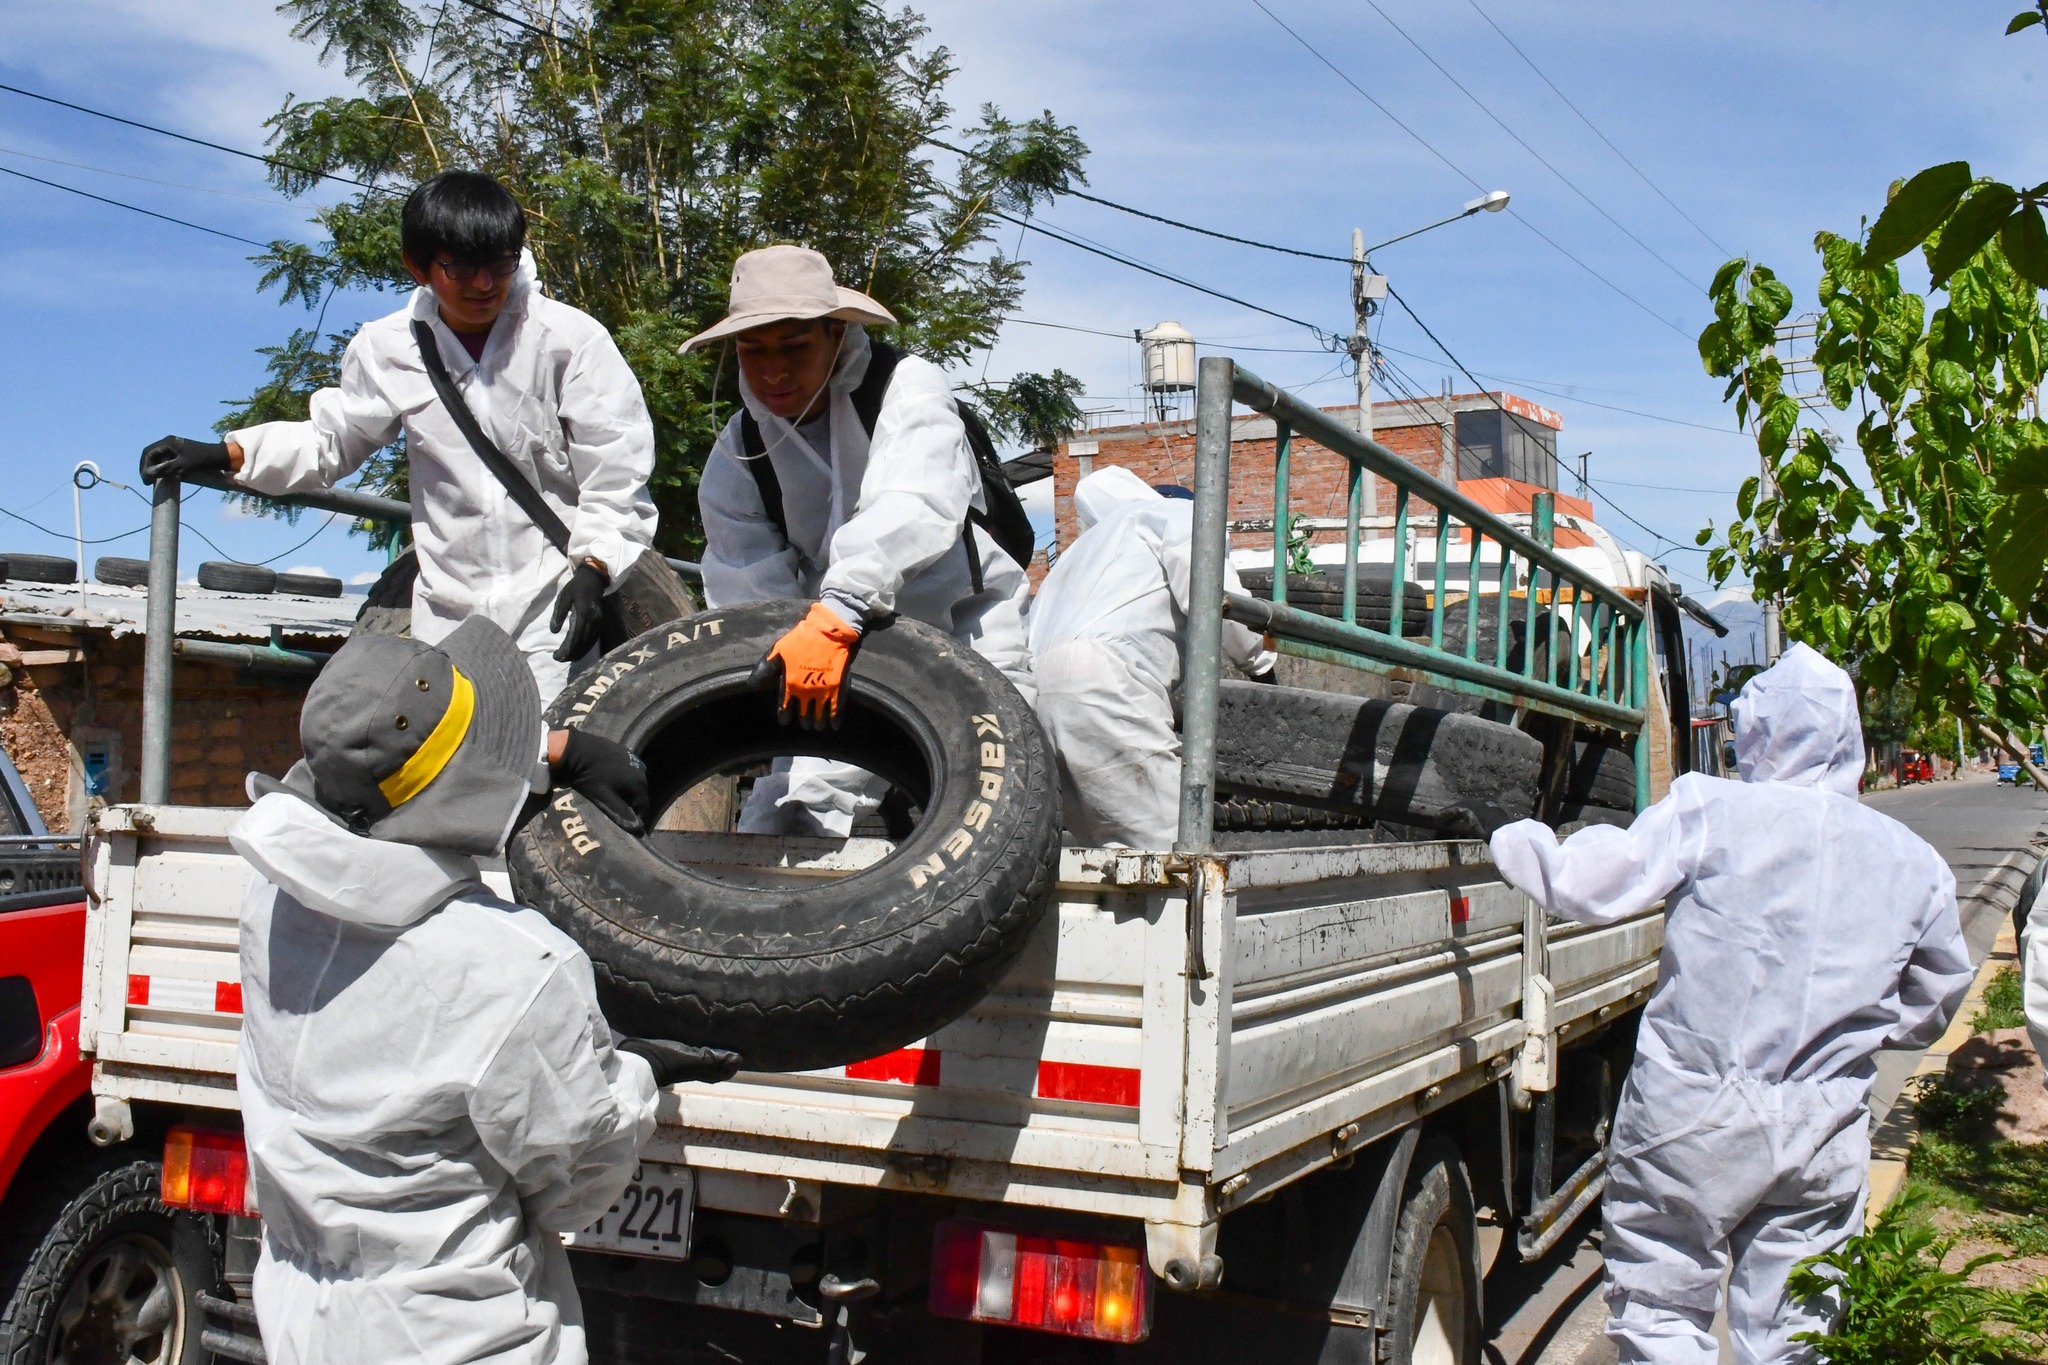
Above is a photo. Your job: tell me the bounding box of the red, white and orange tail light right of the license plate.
[930,1222,1151,1340]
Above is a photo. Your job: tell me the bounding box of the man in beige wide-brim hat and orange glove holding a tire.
[684,246,1030,837]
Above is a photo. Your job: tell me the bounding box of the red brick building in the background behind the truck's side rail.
[1034,393,1556,556]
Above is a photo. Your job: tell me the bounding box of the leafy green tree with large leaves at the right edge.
[1700,0,2048,780]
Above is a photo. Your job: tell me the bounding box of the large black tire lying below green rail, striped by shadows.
[1217,681,1542,839]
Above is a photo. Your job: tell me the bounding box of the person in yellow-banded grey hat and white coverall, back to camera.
[229,618,737,1365]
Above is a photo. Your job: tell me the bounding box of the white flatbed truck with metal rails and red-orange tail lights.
[51,358,1686,1363]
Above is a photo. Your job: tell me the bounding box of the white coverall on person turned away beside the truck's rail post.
[1030,467,1274,849]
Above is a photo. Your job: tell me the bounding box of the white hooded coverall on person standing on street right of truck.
[1493,645,1970,1365]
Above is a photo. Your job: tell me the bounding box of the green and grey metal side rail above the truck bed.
[1176,356,1651,851]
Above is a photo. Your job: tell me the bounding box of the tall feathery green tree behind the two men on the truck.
[221,0,1087,555]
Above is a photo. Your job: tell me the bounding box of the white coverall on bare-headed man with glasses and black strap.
[227,252,655,706]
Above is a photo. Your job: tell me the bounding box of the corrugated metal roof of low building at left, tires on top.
[0,579,362,641]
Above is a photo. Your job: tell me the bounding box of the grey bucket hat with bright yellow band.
[250,616,547,855]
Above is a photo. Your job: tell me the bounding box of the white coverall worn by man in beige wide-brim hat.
[696,323,1030,839]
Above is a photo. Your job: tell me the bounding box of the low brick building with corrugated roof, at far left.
[0,581,362,831]
